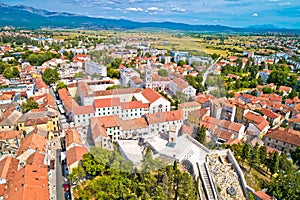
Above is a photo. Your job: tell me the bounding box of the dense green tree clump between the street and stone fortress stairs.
[68,147,198,200]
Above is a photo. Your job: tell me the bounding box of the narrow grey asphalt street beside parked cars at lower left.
[55,149,65,200]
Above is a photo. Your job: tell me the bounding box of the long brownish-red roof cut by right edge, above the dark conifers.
[266,127,300,146]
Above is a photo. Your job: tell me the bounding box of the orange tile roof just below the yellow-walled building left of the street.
[17,134,46,156]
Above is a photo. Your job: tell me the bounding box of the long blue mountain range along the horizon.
[0,4,300,33]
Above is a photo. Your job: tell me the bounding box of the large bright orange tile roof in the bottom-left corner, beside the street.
[4,165,50,200]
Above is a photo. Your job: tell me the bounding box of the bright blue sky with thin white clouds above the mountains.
[0,0,300,28]
